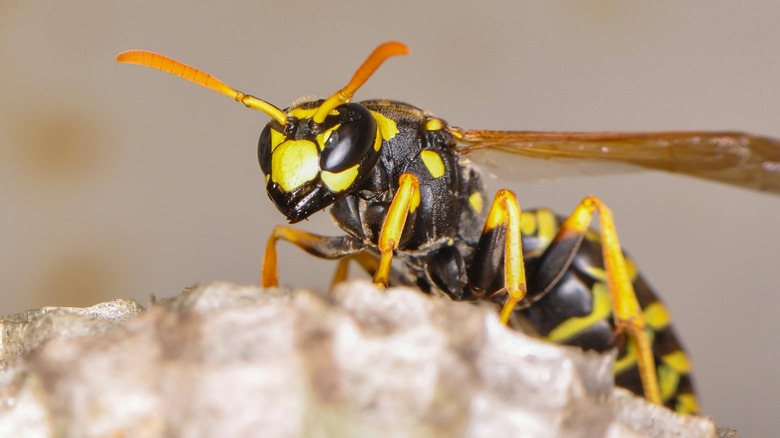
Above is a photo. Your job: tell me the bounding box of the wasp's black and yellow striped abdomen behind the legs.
[519,209,698,413]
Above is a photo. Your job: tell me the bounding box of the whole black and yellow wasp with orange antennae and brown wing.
[117,42,780,413]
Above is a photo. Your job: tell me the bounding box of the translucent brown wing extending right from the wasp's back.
[450,128,780,195]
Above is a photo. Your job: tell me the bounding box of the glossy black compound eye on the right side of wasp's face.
[320,103,377,172]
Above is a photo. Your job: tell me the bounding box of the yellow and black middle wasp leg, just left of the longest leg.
[469,190,528,324]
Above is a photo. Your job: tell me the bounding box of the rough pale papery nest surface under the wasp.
[0,282,717,438]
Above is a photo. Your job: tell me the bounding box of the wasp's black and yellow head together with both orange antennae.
[116,42,409,223]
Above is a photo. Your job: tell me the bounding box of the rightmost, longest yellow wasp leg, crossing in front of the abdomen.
[554,196,662,405]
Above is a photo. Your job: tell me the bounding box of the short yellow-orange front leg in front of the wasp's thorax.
[374,173,420,286]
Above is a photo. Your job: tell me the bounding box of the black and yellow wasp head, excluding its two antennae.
[257,101,382,223]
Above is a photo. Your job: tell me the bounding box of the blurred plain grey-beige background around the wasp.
[0,0,780,437]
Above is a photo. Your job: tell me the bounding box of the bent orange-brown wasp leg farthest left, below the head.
[260,225,365,287]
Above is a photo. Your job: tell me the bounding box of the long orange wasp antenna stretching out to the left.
[116,50,287,125]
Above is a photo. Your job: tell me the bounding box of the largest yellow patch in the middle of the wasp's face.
[271,140,320,193]
